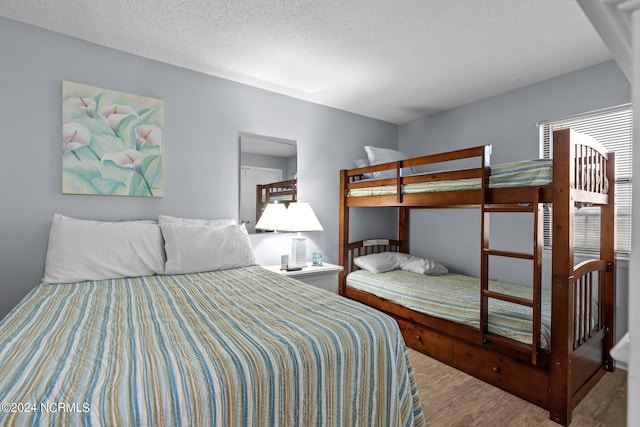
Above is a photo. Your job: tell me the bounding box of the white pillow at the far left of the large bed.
[42,214,164,283]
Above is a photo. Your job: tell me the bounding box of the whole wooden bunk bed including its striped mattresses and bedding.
[339,129,615,425]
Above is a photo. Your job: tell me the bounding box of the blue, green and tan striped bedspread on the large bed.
[0,266,424,426]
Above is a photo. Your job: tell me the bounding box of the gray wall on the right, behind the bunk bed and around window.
[398,61,631,337]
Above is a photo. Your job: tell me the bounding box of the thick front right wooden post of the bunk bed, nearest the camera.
[549,129,575,425]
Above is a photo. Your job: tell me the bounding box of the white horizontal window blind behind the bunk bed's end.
[538,104,633,257]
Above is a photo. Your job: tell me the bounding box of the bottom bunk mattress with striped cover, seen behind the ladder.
[347,270,551,349]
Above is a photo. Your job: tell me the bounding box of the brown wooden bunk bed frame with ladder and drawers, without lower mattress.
[339,129,615,425]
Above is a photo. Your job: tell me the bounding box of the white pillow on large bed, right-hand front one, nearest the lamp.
[160,222,256,274]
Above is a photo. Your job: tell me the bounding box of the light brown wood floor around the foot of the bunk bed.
[409,349,627,427]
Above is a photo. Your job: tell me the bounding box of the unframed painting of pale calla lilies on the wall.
[62,81,164,197]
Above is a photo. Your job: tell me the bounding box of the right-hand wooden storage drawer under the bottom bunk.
[453,339,549,408]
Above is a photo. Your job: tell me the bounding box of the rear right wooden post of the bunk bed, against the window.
[600,153,616,371]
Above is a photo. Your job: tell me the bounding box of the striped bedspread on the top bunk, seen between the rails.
[348,159,553,197]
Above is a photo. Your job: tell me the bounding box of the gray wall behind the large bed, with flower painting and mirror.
[0,18,398,318]
